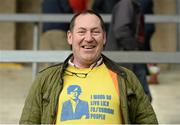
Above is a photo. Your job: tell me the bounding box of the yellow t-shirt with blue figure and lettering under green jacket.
[56,64,122,124]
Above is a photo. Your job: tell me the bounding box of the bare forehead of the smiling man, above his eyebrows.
[74,14,101,27]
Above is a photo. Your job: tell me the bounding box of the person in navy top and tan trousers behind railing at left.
[40,0,73,50]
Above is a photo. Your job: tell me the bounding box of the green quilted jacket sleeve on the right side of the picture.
[127,72,158,124]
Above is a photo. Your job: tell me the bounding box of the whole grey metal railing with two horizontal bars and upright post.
[0,14,180,77]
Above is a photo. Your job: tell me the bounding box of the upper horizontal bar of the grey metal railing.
[0,14,180,23]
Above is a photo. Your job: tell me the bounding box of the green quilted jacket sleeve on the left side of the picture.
[19,73,42,124]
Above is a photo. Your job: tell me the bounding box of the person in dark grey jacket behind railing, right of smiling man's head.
[105,0,152,101]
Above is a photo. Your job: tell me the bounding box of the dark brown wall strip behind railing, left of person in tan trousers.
[16,0,41,50]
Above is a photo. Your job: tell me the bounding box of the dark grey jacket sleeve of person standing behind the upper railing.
[112,0,137,50]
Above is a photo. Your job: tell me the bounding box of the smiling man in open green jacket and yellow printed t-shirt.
[20,10,157,124]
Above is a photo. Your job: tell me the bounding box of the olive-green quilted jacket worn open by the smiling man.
[20,55,158,124]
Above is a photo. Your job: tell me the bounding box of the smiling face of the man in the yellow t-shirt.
[67,14,106,68]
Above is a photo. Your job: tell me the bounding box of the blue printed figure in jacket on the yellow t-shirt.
[61,85,89,121]
